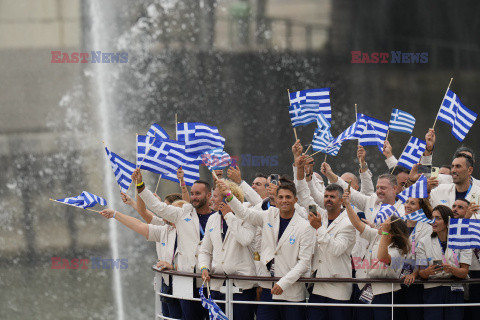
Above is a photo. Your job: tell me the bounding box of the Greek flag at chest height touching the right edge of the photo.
[448,218,480,249]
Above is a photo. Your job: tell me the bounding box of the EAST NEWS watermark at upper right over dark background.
[350,51,428,64]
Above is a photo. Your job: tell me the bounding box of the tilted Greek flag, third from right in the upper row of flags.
[357,113,388,152]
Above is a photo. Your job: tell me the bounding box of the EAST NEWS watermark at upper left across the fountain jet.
[51,51,128,63]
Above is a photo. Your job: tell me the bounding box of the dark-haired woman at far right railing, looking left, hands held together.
[417,205,472,320]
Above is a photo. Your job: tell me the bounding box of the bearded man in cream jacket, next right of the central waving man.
[295,156,355,320]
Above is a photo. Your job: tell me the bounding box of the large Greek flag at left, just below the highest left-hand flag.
[137,135,201,185]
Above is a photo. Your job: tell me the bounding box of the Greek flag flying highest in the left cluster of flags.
[177,122,225,155]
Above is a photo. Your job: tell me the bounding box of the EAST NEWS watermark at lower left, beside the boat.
[51,257,128,270]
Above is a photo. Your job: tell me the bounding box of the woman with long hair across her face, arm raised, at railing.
[343,192,410,320]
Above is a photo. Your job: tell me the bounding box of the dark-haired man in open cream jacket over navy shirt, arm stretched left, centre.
[217,181,315,320]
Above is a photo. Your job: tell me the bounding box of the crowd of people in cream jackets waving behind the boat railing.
[97,129,480,320]
